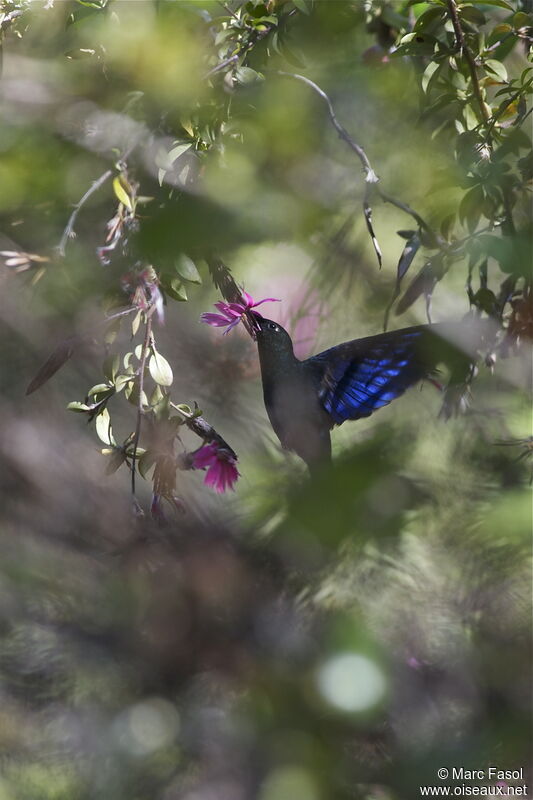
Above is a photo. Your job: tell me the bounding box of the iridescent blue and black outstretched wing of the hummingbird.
[306,326,434,425]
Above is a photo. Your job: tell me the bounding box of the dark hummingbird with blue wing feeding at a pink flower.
[256,315,486,471]
